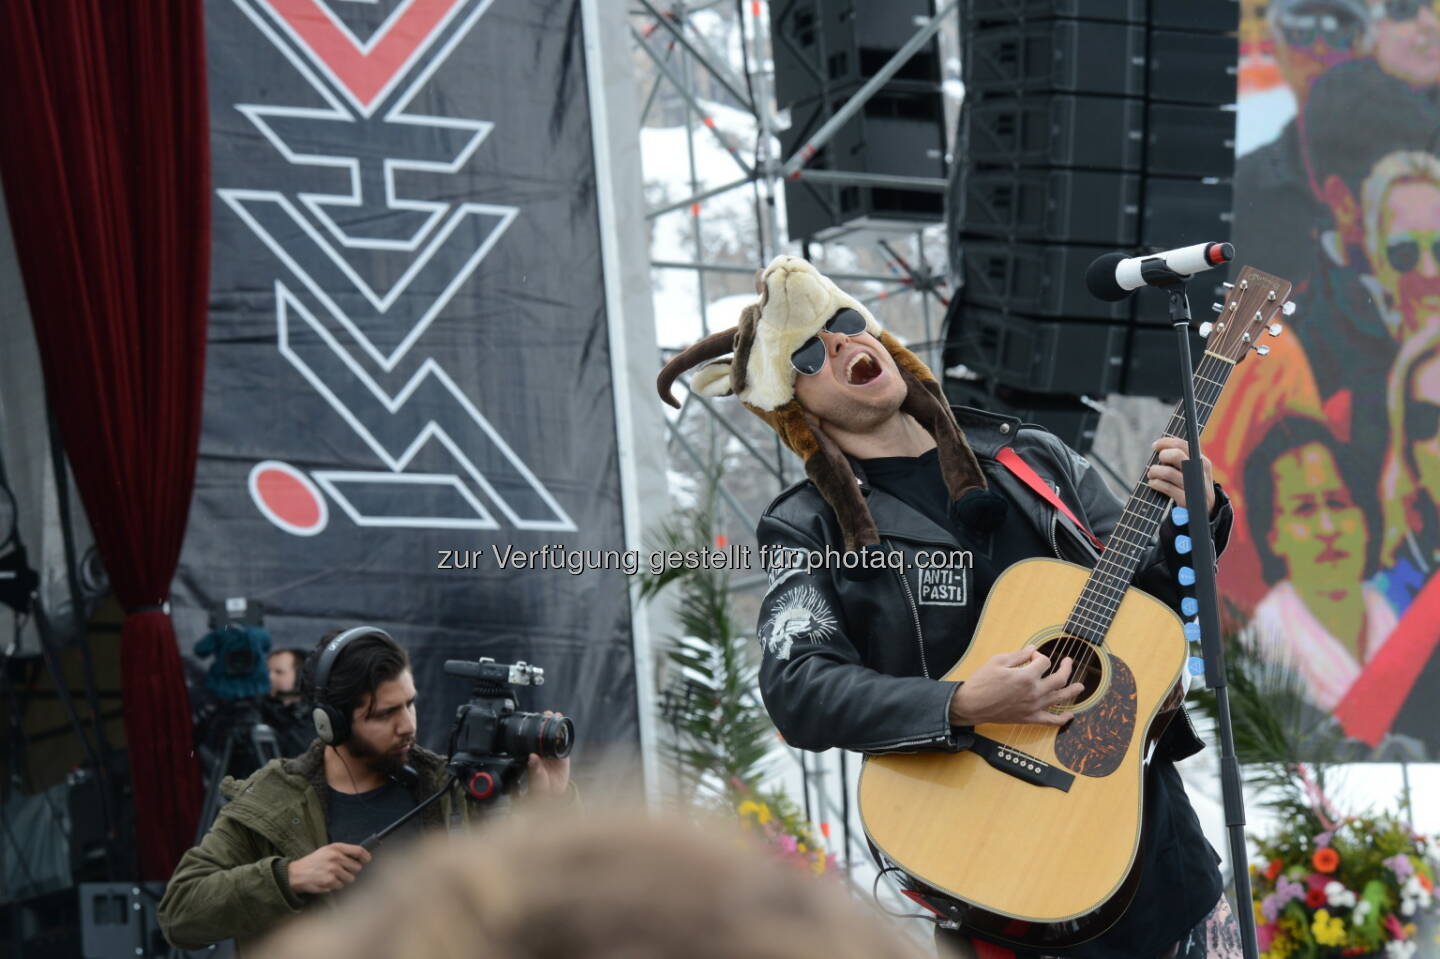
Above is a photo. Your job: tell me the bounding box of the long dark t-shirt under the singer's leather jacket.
[861,449,1221,959]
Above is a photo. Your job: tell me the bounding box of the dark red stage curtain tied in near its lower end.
[0,0,210,878]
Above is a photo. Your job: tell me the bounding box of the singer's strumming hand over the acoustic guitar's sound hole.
[950,649,1084,726]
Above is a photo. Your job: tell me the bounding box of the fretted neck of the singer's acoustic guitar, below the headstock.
[1066,345,1234,644]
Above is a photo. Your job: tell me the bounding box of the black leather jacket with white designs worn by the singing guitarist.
[757,408,1233,760]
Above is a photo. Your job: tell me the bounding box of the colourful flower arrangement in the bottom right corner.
[1250,809,1440,959]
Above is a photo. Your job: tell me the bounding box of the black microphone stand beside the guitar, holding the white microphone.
[1140,259,1259,959]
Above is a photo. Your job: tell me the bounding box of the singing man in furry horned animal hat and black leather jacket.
[657,251,1240,959]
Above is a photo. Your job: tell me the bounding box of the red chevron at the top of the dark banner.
[262,0,464,108]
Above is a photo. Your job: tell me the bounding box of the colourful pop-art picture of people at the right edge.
[1208,0,1440,760]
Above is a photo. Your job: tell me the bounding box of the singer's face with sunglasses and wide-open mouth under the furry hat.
[791,310,906,432]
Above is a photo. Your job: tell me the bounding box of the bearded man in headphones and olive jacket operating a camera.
[158,626,573,950]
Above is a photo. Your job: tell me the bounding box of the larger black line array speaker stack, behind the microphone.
[945,0,1240,451]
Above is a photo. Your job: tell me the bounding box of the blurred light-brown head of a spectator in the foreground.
[259,812,922,959]
